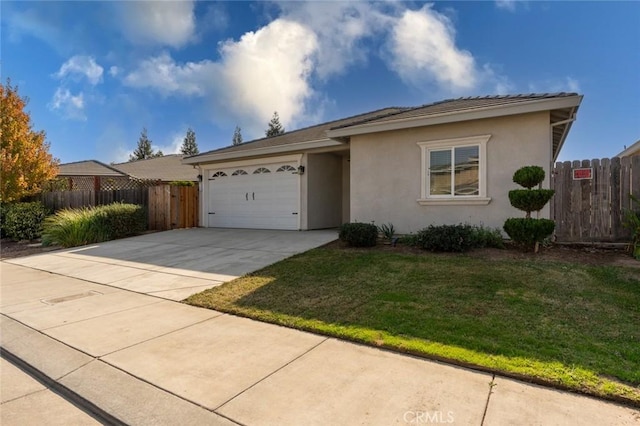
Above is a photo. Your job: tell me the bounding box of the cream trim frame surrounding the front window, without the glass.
[416,135,491,206]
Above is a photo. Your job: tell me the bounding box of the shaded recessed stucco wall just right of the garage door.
[305,154,342,229]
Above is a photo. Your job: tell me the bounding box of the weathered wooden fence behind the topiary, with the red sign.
[551,156,640,242]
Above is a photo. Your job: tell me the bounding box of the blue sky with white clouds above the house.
[0,0,640,163]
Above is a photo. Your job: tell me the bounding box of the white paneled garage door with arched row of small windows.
[208,163,299,230]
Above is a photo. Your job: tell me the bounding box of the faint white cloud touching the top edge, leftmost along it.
[116,0,196,47]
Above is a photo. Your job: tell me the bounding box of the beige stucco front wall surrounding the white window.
[350,112,552,233]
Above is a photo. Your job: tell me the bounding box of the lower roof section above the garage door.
[183,107,407,164]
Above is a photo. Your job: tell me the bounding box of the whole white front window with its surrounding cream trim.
[418,135,491,205]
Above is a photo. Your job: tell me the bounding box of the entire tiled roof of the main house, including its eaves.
[183,92,582,164]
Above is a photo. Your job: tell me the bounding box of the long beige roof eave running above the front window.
[327,95,582,139]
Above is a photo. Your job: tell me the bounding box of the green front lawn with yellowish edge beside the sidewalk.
[186,247,640,405]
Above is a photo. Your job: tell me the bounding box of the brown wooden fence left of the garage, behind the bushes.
[41,185,199,231]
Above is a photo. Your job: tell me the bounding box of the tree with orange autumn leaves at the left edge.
[0,79,58,203]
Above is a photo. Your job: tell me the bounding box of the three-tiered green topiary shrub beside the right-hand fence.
[503,166,555,253]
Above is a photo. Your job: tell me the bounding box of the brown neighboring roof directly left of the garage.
[113,154,198,182]
